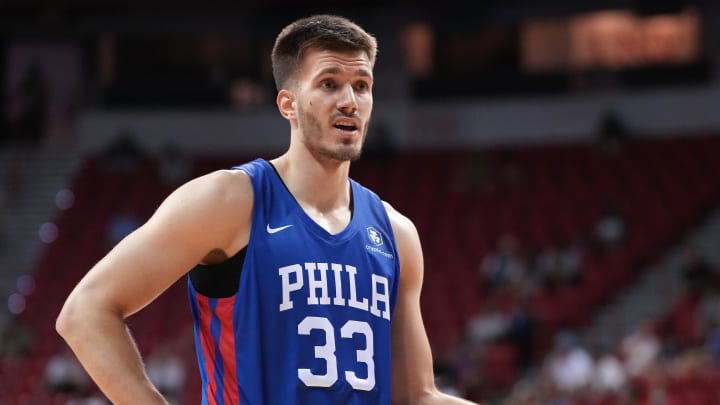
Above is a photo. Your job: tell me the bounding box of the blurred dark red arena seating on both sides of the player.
[8,136,720,404]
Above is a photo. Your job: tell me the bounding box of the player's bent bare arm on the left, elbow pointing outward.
[56,171,252,405]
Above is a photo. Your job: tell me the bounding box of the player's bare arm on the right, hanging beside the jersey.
[386,204,480,405]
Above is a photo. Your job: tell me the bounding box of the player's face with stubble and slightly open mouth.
[296,49,373,162]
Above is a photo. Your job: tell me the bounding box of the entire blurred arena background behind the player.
[0,0,720,405]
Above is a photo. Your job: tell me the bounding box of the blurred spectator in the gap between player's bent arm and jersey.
[146,344,186,404]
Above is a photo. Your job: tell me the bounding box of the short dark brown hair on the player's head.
[271,14,377,91]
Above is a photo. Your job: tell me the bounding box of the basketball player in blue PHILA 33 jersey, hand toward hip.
[57,15,478,405]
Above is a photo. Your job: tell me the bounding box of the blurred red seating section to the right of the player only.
[355,136,720,394]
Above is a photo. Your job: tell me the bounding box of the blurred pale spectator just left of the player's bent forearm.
[44,346,90,396]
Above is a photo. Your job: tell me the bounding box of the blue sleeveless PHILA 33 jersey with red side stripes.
[188,159,400,405]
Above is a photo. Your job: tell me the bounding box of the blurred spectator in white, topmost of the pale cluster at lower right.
[620,322,662,378]
